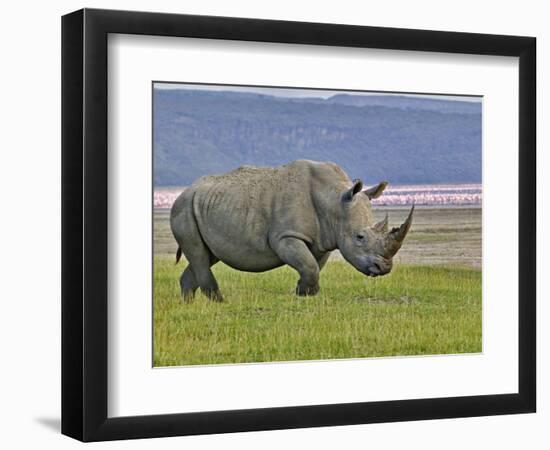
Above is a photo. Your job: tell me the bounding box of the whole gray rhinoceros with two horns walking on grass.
[170,160,414,301]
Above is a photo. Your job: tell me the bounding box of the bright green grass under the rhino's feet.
[154,256,481,366]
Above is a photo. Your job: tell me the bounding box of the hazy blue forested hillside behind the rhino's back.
[154,89,481,187]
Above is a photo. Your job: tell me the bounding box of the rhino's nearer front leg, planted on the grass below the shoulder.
[274,237,319,295]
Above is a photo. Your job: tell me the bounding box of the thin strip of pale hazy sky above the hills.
[154,83,482,103]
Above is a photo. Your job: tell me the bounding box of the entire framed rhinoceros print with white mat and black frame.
[62,9,536,441]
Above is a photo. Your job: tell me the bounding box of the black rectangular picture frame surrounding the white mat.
[62,9,536,441]
